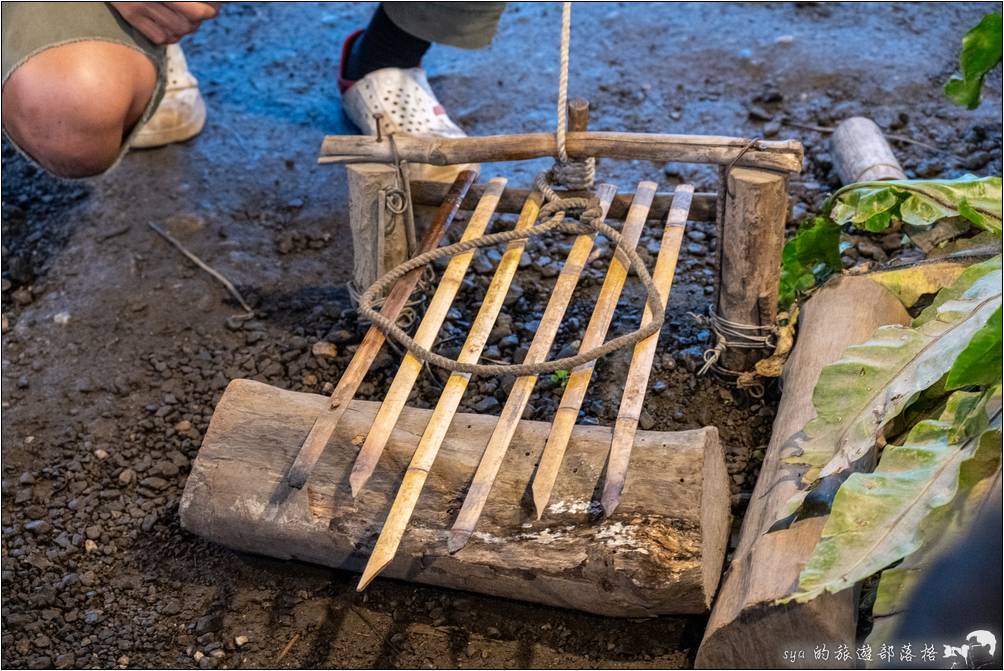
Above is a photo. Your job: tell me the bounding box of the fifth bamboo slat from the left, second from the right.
[531,182,657,519]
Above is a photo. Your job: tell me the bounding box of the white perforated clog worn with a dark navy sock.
[338,31,478,182]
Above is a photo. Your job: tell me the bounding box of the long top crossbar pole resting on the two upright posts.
[318,131,803,173]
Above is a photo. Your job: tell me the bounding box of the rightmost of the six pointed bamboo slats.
[600,184,694,517]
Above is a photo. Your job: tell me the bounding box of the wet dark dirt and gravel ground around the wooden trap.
[2,3,1001,668]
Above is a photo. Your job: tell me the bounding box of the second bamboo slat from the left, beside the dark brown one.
[348,177,506,498]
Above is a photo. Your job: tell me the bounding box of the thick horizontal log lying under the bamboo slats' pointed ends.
[179,380,729,617]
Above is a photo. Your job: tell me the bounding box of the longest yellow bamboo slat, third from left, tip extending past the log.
[356,191,542,592]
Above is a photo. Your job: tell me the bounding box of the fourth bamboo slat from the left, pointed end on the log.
[447,184,616,552]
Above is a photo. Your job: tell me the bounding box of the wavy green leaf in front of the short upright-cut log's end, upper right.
[830,175,1004,236]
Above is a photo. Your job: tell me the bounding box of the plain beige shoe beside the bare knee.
[131,44,206,149]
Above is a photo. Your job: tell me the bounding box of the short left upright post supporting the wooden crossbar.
[346,163,407,291]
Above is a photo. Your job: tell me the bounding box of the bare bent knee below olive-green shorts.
[3,44,156,177]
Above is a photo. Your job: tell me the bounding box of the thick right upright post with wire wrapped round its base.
[718,168,788,371]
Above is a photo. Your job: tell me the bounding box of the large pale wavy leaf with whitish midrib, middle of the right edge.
[785,260,1002,480]
